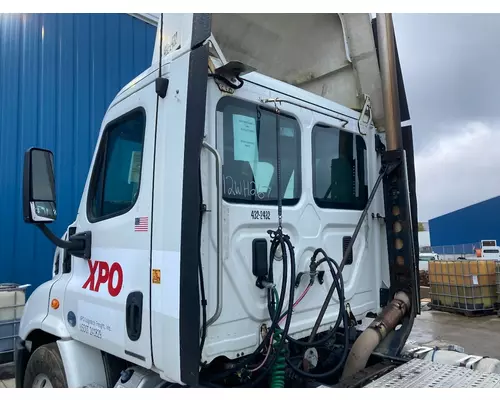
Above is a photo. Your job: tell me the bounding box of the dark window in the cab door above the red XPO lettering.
[87,109,146,222]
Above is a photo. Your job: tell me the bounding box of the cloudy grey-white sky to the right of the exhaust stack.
[393,14,500,221]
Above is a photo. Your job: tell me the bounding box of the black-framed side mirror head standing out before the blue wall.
[23,148,57,223]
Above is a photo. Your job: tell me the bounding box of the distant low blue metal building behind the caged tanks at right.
[429,196,500,254]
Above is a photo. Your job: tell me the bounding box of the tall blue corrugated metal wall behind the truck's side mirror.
[0,14,156,296]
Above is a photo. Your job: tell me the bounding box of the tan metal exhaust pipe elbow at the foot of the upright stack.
[341,292,410,381]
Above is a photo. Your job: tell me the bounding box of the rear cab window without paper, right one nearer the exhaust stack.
[312,125,368,210]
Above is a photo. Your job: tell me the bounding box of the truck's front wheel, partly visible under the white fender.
[24,343,68,388]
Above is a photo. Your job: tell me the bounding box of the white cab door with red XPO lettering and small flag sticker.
[63,81,157,368]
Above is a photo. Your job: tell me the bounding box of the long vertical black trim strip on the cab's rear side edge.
[179,14,211,386]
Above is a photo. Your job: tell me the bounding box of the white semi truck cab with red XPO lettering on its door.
[16,14,418,387]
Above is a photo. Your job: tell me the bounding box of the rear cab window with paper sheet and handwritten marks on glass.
[217,97,302,206]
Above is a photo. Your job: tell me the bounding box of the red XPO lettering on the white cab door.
[82,260,123,297]
